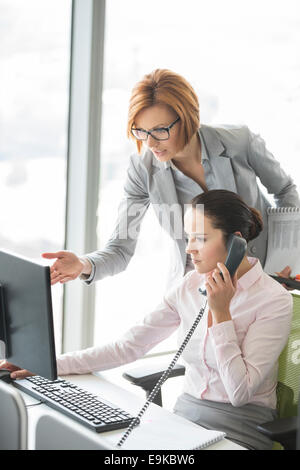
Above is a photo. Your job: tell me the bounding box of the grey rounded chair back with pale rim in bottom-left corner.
[0,380,27,450]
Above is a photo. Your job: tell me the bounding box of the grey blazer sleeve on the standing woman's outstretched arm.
[82,156,150,284]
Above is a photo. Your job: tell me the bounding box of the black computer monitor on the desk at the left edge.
[0,251,57,380]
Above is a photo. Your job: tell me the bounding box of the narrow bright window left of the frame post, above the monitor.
[0,0,71,352]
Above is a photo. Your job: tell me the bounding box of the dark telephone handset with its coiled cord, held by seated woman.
[117,234,247,447]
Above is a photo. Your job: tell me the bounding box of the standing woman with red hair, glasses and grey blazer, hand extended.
[43,69,300,284]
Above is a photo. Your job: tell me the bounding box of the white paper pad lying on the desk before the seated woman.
[105,414,225,450]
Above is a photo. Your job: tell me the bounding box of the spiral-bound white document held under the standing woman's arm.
[264,207,300,276]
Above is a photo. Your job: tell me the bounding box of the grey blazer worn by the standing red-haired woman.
[86,125,300,284]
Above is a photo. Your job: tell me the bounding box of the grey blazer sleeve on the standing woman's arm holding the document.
[248,130,300,207]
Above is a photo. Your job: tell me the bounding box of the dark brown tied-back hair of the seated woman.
[191,189,263,242]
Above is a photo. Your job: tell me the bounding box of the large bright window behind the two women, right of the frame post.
[95,0,300,350]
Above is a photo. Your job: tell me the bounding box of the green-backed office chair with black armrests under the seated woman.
[123,294,300,450]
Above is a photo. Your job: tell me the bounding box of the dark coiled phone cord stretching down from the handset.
[117,299,207,447]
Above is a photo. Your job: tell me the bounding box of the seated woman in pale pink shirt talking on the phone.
[1,190,292,449]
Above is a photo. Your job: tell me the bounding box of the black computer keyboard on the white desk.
[14,376,138,432]
